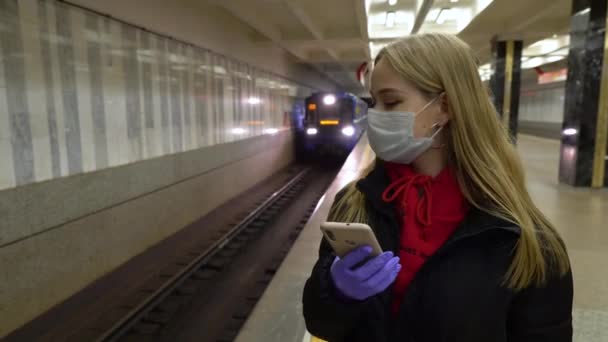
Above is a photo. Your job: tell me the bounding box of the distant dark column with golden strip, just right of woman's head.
[490,40,523,141]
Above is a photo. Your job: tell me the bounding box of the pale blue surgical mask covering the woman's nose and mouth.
[367,97,442,164]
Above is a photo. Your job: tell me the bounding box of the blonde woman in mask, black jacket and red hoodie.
[303,34,572,342]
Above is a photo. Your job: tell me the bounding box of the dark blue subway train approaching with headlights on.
[296,92,368,156]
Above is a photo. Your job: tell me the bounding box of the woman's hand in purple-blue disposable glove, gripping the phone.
[330,246,401,300]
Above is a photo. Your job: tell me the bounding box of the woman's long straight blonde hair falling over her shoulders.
[330,33,570,289]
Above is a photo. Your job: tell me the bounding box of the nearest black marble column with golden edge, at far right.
[559,0,608,188]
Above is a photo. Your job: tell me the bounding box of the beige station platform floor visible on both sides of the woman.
[236,135,608,342]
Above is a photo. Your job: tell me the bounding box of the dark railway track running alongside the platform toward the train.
[75,164,334,342]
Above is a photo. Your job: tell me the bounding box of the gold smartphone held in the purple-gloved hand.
[321,222,382,258]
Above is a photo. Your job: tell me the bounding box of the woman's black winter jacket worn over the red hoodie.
[303,164,573,342]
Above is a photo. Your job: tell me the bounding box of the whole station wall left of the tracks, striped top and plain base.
[0,0,335,337]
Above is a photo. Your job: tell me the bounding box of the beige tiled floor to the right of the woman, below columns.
[518,136,608,342]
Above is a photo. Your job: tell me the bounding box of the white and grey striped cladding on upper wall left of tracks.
[0,0,313,190]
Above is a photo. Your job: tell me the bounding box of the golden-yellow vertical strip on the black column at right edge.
[591,5,608,188]
